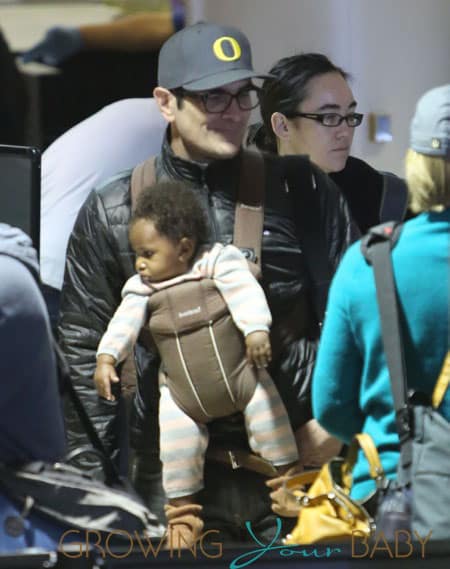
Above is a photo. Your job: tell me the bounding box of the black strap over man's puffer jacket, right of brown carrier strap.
[282,156,332,323]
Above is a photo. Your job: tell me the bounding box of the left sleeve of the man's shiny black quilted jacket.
[59,184,126,467]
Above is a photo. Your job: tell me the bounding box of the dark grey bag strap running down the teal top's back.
[361,222,411,443]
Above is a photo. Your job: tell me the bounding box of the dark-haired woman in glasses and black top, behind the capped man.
[250,53,406,234]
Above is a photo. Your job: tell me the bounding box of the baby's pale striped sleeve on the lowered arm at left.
[97,277,149,363]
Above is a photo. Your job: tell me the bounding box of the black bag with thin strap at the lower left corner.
[0,342,165,540]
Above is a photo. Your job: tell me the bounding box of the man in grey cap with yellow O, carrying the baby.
[60,23,352,541]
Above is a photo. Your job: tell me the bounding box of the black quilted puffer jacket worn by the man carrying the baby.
[60,135,354,464]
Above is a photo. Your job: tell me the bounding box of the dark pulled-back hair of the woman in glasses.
[253,53,350,153]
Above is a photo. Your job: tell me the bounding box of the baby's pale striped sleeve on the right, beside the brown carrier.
[209,245,272,336]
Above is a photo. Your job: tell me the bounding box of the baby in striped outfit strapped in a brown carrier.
[95,182,298,542]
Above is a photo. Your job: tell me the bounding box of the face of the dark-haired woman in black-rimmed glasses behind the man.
[289,73,356,173]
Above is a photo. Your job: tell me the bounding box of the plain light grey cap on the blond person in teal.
[410,84,450,156]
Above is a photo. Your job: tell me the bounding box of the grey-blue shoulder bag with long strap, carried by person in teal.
[361,222,450,540]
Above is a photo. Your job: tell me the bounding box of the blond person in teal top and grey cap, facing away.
[312,84,450,499]
